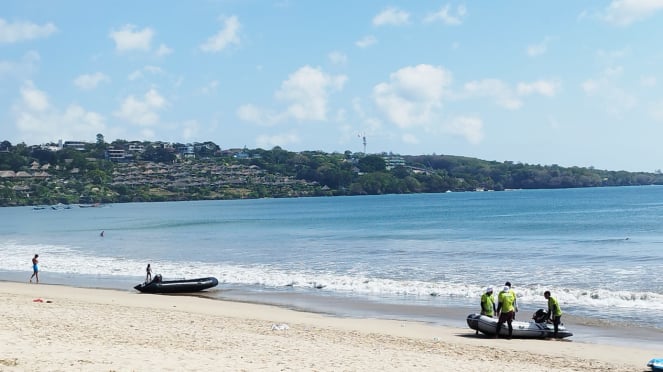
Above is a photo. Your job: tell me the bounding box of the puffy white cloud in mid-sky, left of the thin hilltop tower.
[237,66,347,125]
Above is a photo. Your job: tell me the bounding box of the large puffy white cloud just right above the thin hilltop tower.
[373,64,452,128]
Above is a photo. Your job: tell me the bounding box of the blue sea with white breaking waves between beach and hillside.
[0,186,663,346]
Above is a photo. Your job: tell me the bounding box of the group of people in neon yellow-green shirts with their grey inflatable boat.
[467,282,572,339]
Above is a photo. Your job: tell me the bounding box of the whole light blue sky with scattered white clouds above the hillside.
[0,0,663,171]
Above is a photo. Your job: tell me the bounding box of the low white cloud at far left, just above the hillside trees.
[12,81,106,143]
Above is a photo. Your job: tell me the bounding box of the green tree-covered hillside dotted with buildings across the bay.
[0,136,663,206]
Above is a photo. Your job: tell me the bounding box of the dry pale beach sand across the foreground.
[0,282,653,372]
